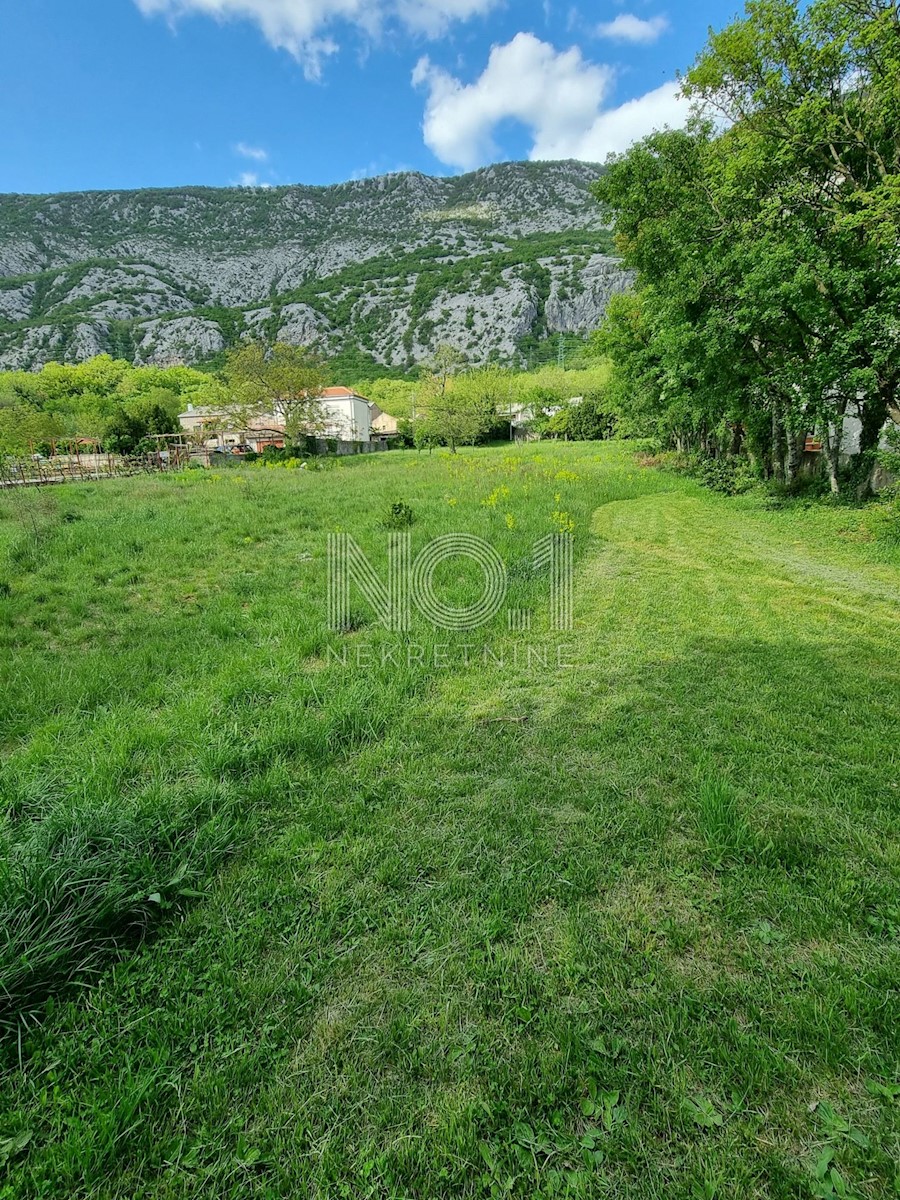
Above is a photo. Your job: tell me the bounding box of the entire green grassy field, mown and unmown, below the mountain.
[0,445,900,1200]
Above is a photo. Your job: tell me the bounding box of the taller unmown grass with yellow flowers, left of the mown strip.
[0,448,657,1030]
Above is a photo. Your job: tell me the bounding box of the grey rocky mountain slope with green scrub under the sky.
[0,162,630,370]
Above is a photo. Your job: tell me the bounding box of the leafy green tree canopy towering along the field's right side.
[596,0,900,490]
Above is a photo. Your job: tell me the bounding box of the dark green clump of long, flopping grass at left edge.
[0,788,241,1028]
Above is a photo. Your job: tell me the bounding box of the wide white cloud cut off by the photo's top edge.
[134,0,503,79]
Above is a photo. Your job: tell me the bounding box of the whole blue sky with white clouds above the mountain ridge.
[0,0,737,192]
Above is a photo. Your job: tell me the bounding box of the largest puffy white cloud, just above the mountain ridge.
[413,34,688,169]
